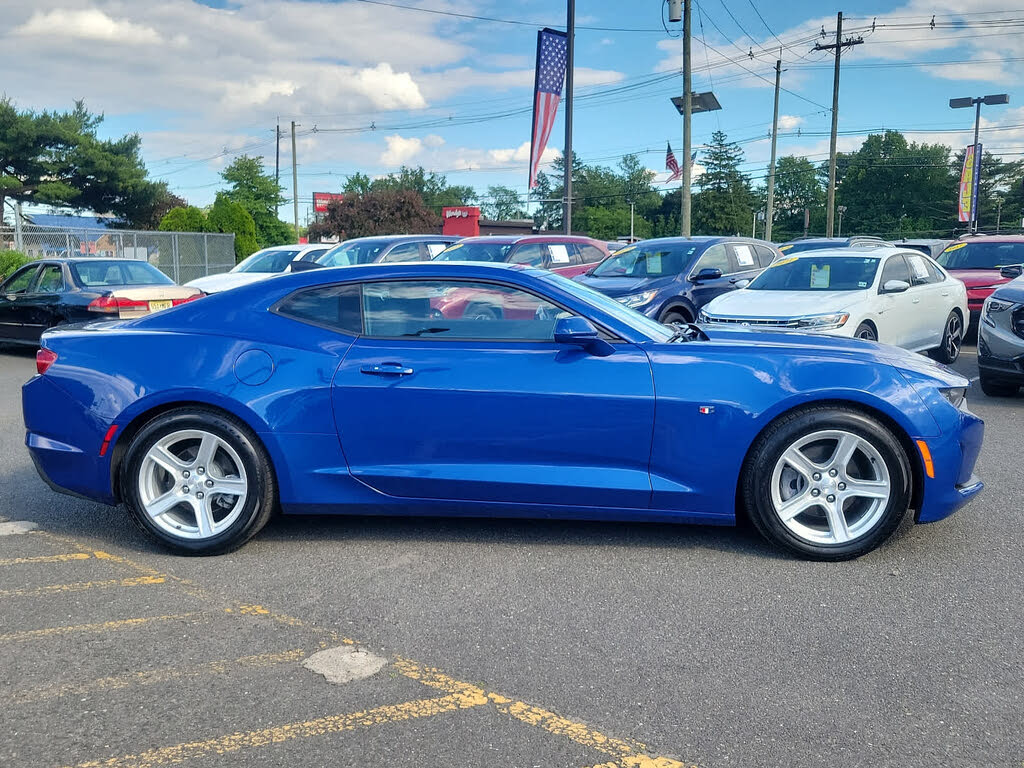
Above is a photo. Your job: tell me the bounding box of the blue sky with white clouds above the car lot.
[0,0,1024,221]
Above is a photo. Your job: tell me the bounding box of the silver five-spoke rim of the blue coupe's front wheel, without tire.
[771,429,892,544]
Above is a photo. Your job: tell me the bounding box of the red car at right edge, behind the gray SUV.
[936,240,1024,323]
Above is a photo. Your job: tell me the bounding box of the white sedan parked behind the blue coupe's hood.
[698,247,970,364]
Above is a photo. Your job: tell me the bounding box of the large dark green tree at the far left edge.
[0,99,158,221]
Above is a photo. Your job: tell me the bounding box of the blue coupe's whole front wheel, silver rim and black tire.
[741,407,912,560]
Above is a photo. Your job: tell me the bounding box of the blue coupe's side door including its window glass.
[332,279,654,509]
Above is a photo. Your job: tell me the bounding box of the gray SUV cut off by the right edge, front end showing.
[978,266,1024,397]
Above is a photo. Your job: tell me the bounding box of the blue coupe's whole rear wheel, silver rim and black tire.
[121,409,275,555]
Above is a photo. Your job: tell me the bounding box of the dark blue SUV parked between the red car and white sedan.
[575,237,779,323]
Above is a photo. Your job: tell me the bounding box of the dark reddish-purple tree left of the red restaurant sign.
[309,189,441,242]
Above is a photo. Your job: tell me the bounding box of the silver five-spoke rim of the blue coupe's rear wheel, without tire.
[138,429,249,541]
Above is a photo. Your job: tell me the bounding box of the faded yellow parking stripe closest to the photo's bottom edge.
[68,693,487,768]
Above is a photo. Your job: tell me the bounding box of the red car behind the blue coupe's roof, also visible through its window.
[431,234,608,319]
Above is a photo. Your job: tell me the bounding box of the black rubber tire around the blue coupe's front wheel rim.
[740,406,913,561]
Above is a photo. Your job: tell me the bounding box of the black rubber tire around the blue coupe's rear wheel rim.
[119,408,276,555]
